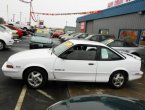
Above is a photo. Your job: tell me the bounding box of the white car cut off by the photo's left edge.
[0,27,14,51]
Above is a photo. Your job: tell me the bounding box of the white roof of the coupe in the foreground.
[69,39,107,47]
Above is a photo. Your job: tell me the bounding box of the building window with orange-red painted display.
[119,30,139,42]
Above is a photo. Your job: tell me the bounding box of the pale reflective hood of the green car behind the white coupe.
[30,36,52,44]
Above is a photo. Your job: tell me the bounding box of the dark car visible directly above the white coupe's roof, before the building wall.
[85,34,115,42]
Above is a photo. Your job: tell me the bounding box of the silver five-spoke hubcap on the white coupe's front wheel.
[28,71,43,87]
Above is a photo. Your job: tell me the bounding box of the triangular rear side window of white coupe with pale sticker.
[100,47,123,61]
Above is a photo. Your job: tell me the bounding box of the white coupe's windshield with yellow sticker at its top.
[52,41,73,56]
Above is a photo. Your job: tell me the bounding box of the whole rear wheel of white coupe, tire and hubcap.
[109,71,127,89]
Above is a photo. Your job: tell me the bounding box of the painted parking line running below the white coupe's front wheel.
[15,85,27,110]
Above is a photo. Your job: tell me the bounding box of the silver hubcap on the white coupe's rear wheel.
[112,73,124,87]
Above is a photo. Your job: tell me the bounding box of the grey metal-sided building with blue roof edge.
[76,0,145,45]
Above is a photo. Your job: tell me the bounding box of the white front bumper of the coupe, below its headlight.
[2,62,22,79]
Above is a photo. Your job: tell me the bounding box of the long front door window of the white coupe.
[60,45,98,60]
